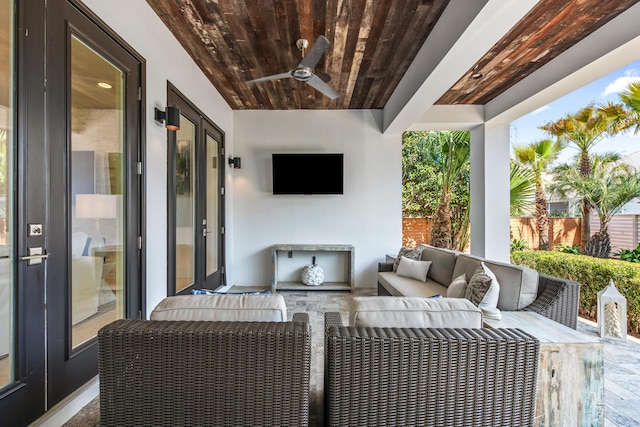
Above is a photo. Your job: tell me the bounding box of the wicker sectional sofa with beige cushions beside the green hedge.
[378,245,580,329]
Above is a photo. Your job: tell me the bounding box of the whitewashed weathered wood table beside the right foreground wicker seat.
[484,311,604,427]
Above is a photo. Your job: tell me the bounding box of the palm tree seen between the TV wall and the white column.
[429,131,471,249]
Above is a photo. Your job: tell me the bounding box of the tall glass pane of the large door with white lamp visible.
[69,36,125,347]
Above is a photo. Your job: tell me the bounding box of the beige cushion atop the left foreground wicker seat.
[150,294,287,322]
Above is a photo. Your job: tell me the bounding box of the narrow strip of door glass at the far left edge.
[0,0,16,388]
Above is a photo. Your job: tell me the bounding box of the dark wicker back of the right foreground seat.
[325,310,540,426]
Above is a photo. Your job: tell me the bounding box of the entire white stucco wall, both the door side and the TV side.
[76,0,402,313]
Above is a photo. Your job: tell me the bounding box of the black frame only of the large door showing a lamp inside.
[46,0,146,408]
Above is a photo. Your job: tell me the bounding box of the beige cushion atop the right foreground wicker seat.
[349,296,482,328]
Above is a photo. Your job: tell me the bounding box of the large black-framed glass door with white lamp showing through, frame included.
[47,2,142,403]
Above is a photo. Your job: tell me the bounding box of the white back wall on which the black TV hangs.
[227,110,402,287]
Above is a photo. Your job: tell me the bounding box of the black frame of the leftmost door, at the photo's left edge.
[0,0,47,425]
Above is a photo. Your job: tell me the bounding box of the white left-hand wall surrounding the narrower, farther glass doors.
[84,0,233,313]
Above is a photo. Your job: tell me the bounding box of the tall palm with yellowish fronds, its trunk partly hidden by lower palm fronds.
[540,104,616,253]
